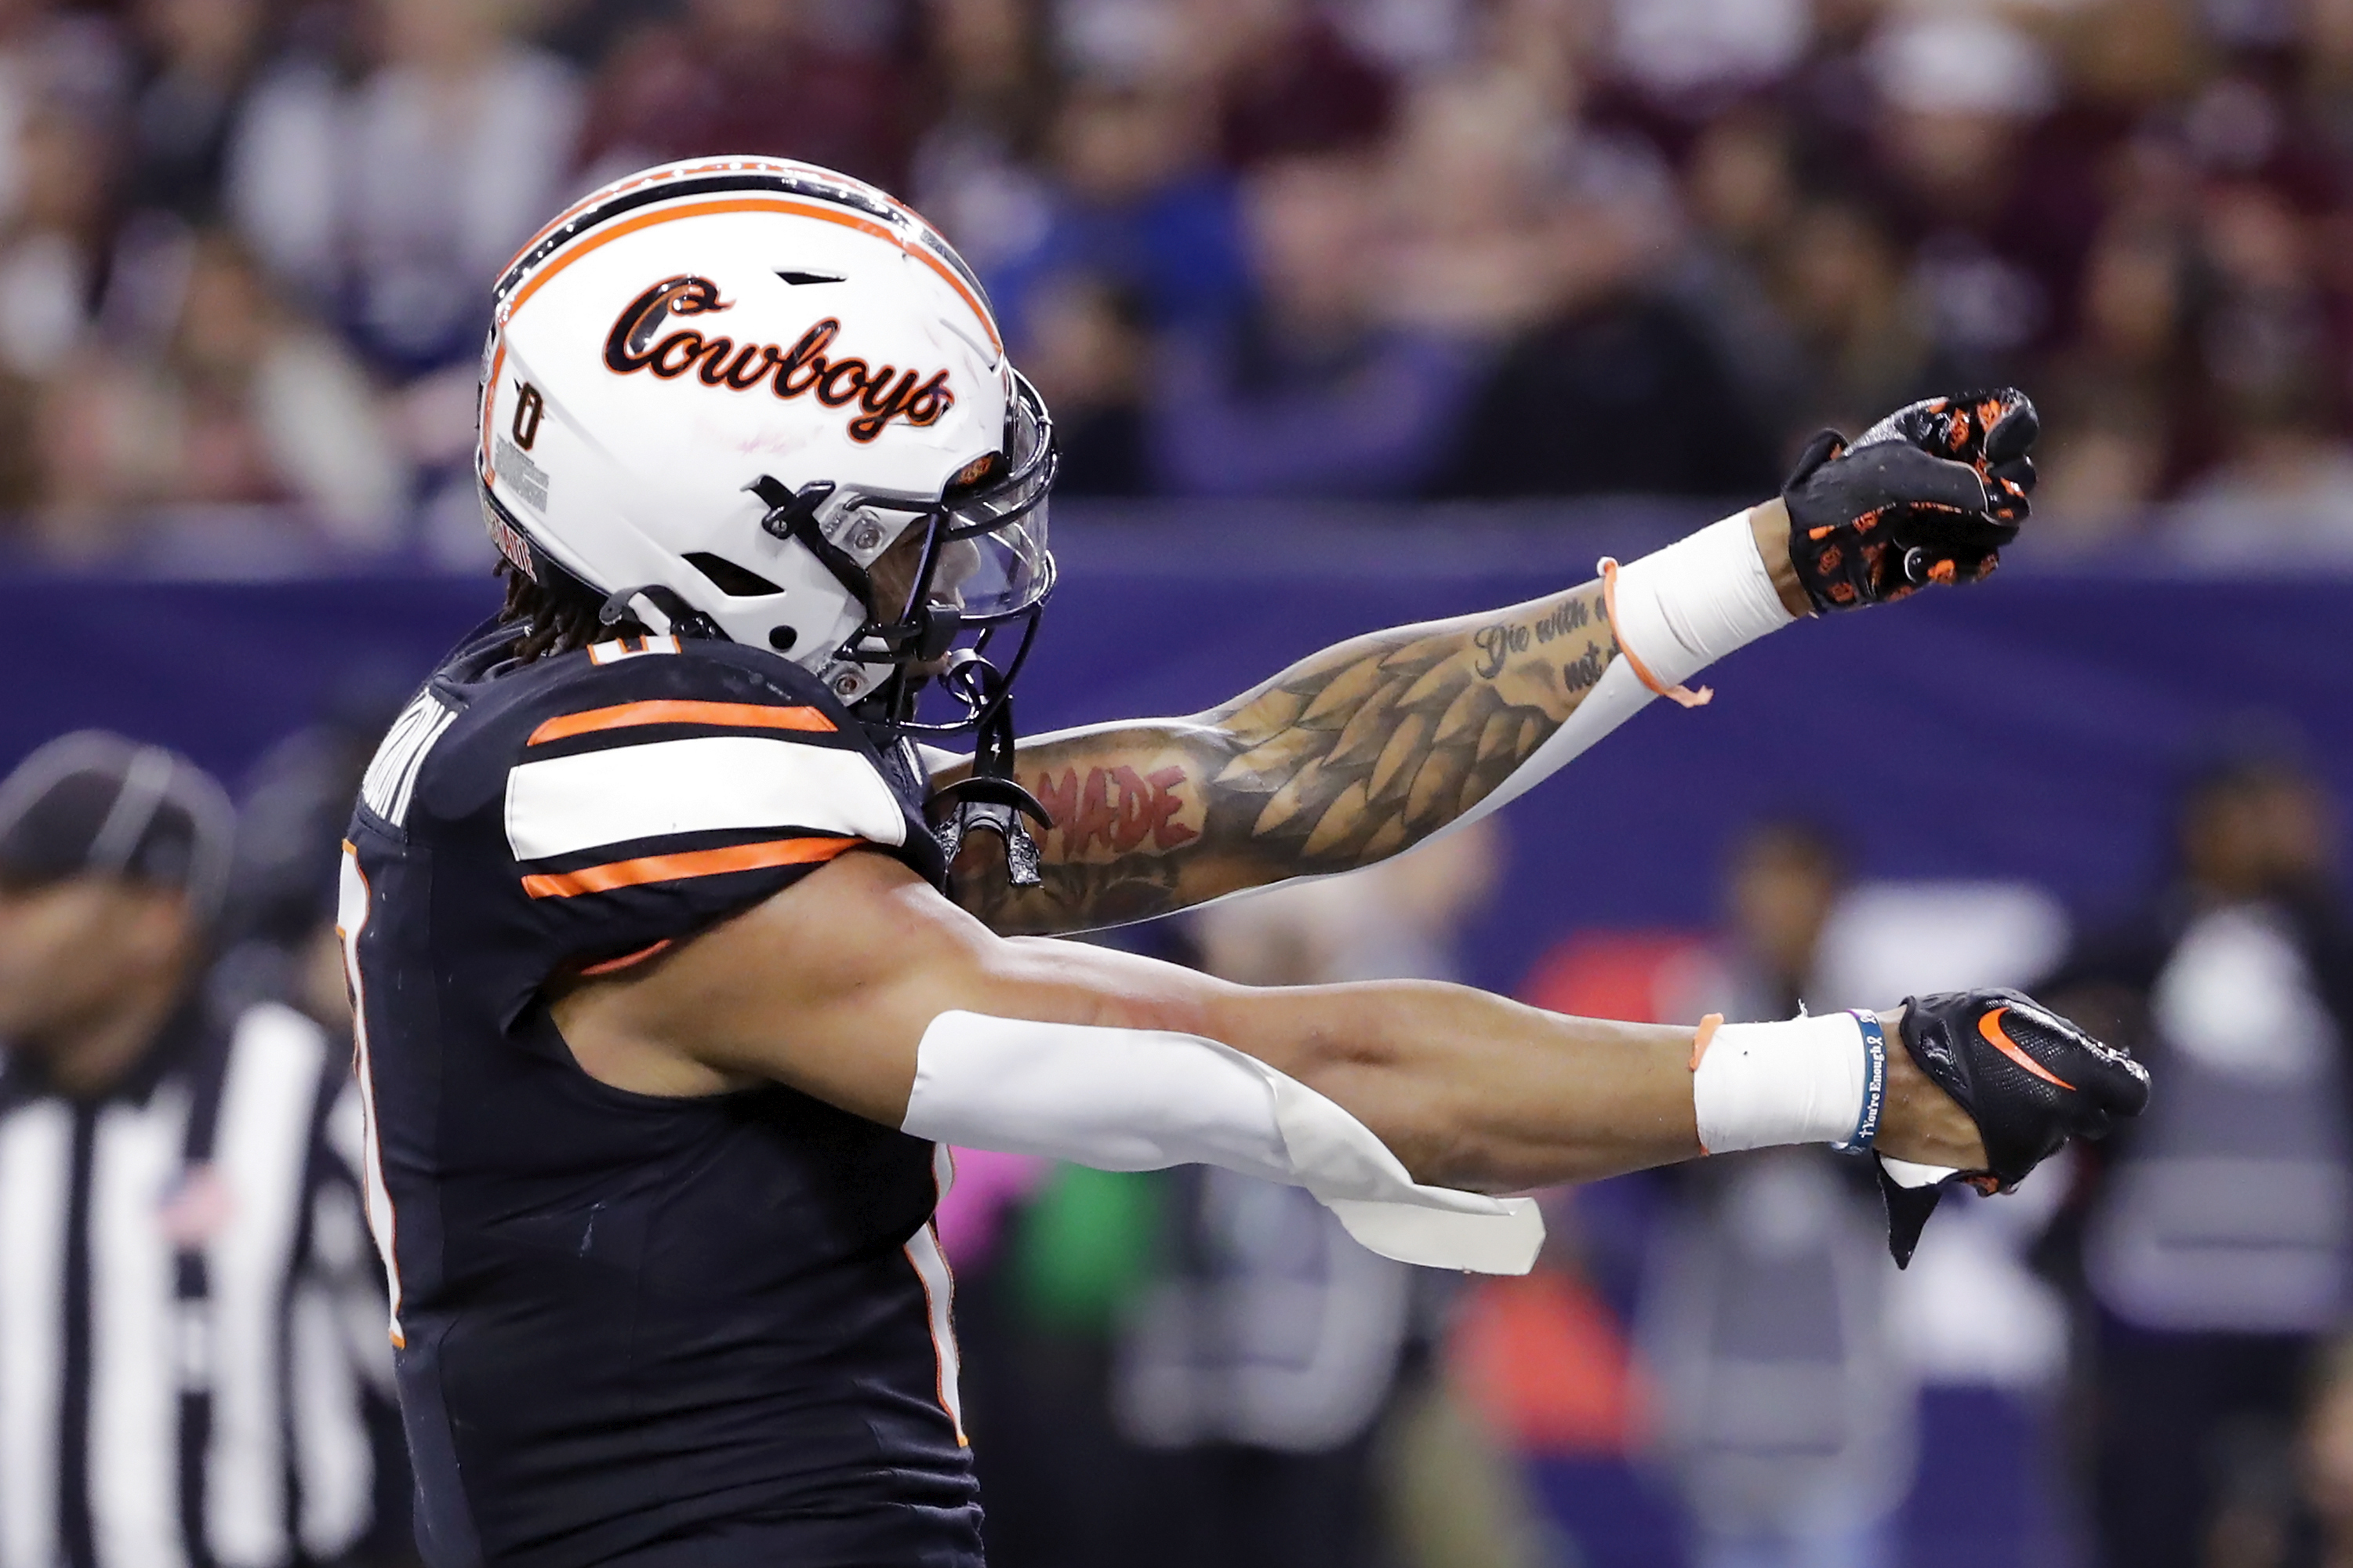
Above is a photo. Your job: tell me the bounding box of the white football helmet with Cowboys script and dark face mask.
[475,158,1056,730]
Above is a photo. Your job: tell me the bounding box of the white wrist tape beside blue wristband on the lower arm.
[1692,1012,1871,1153]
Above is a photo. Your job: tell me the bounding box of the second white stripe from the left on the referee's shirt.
[89,1085,188,1568]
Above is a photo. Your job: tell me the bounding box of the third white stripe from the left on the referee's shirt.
[205,1005,325,1568]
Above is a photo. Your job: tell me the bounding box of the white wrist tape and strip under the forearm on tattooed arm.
[1452,511,1798,826]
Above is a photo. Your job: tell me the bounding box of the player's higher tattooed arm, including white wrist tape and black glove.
[941,390,2038,932]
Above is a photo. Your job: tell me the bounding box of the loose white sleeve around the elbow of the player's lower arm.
[899,1012,1544,1274]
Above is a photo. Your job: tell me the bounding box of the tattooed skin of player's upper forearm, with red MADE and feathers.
[936,584,1617,932]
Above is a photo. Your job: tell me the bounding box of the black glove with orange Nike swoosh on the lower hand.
[1880,991,2148,1269]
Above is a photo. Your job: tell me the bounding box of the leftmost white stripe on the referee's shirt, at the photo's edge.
[0,1102,73,1568]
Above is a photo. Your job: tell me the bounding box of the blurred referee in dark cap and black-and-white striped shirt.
[0,732,390,1568]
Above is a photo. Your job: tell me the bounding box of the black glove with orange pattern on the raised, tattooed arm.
[1781,386,2043,615]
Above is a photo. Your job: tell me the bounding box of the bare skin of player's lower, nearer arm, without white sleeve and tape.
[555,855,1984,1192]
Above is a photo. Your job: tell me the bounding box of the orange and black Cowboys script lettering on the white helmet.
[607,275,955,443]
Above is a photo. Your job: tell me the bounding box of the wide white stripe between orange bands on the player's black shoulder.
[506,735,906,859]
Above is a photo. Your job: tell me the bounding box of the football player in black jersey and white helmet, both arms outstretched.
[341,158,2146,1568]
